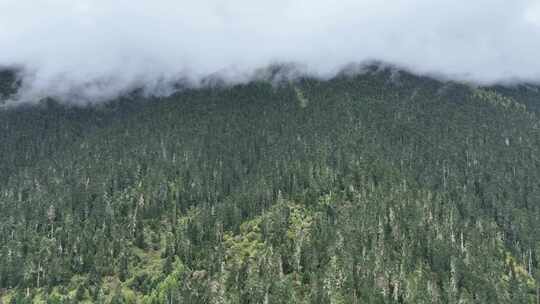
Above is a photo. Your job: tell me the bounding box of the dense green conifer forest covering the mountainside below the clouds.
[0,69,540,304]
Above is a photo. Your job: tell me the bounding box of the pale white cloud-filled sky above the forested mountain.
[0,0,540,99]
